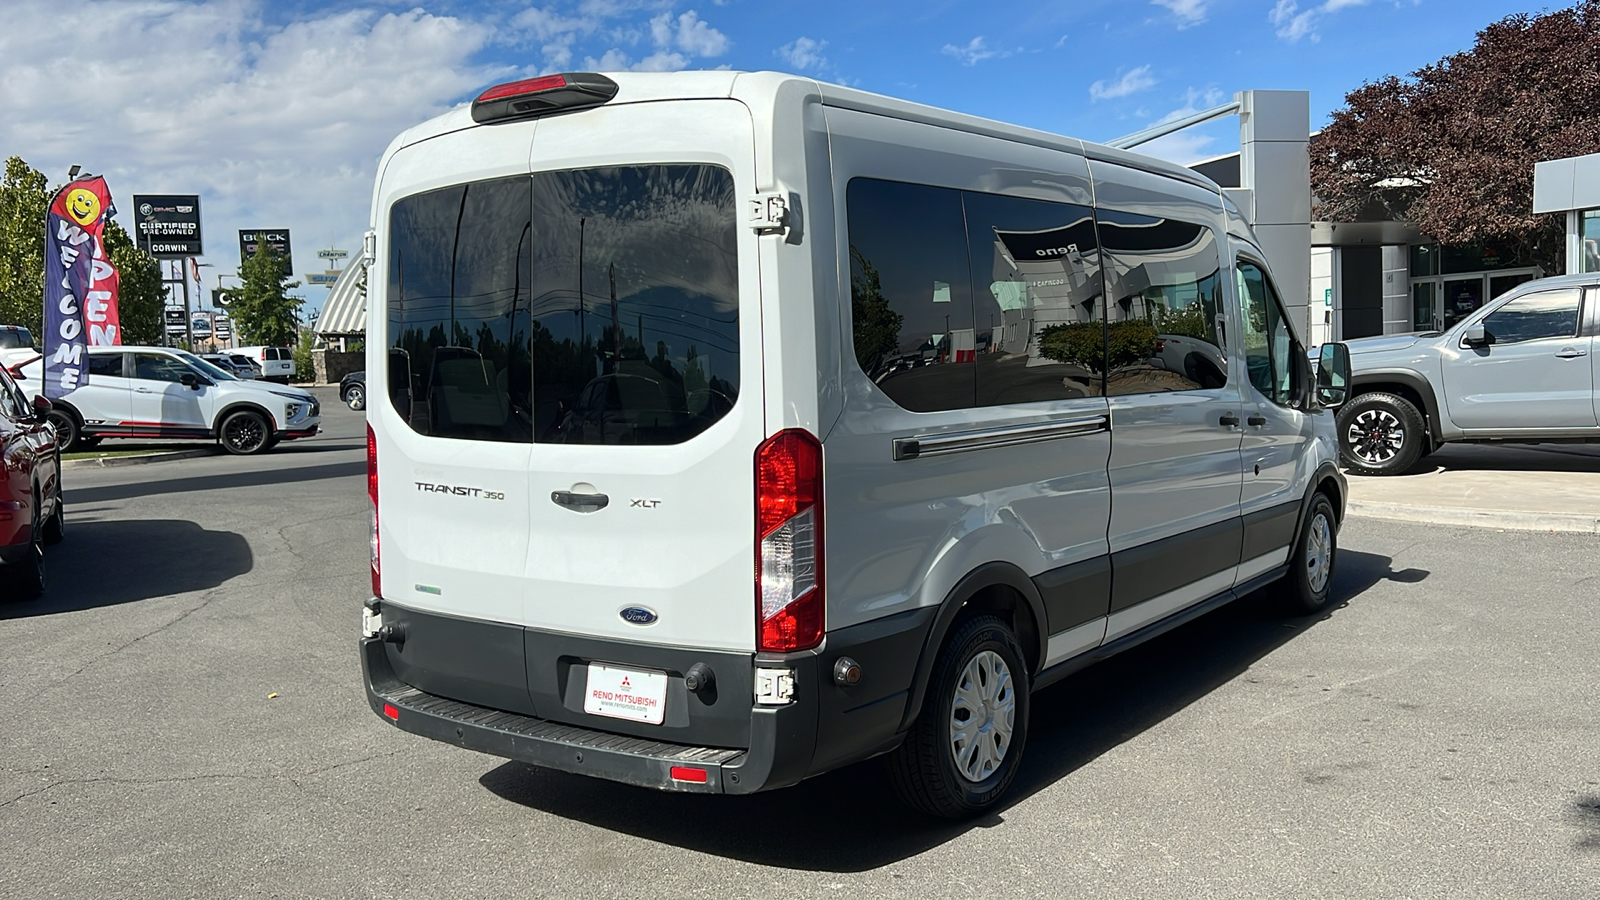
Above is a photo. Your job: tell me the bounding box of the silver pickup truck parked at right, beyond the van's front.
[1339,272,1600,476]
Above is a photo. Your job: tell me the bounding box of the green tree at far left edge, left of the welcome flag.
[0,157,50,335]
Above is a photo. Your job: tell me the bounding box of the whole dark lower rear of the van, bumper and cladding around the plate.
[360,601,934,794]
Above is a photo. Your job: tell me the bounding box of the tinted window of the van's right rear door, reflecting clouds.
[531,165,739,444]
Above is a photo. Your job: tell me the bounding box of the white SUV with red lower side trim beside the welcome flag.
[14,348,322,453]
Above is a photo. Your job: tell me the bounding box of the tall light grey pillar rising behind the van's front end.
[1235,91,1322,340]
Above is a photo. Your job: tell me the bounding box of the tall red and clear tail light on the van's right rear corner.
[755,429,824,653]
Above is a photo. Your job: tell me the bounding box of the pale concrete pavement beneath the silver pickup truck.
[1349,444,1600,535]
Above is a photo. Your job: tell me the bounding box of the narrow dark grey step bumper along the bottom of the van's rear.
[362,637,816,794]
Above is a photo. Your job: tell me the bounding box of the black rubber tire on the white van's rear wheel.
[890,615,1030,818]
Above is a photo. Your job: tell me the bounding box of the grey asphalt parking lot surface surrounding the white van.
[0,392,1600,900]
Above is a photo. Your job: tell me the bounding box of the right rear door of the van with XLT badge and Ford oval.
[523,99,765,650]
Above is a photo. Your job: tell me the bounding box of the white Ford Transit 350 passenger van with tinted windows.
[360,72,1349,817]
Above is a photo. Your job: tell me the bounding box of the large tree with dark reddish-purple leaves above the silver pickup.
[1310,0,1600,274]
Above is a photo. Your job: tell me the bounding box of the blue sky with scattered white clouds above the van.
[0,0,1548,320]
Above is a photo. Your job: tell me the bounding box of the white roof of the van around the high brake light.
[393,70,1221,192]
